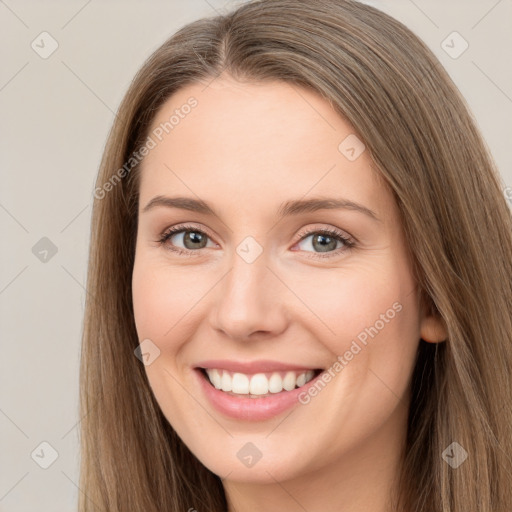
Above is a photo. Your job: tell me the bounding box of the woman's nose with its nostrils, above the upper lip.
[211,247,290,341]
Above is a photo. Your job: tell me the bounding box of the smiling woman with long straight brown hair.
[80,0,512,512]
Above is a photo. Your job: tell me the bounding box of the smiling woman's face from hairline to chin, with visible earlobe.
[133,77,448,482]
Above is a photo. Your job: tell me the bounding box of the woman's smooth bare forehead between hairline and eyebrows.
[140,78,392,220]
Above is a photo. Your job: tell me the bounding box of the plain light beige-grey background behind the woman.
[0,0,512,512]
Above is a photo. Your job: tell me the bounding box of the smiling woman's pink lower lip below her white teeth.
[195,369,322,421]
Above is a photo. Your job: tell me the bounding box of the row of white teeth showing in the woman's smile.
[206,368,315,396]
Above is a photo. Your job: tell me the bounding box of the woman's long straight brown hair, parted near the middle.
[80,0,512,512]
